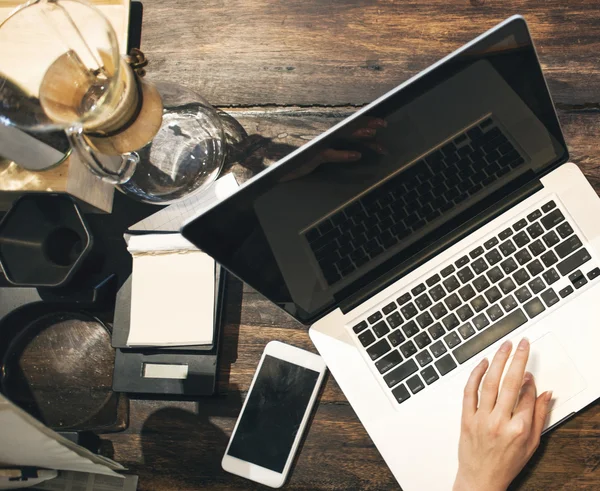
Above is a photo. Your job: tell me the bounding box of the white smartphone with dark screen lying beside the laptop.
[221,341,326,488]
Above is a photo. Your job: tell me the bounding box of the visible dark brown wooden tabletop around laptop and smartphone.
[103,0,600,491]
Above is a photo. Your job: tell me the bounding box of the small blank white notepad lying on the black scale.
[127,234,215,347]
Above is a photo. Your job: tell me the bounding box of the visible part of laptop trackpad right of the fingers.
[527,332,586,411]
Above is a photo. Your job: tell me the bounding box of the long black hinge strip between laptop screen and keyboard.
[339,179,544,314]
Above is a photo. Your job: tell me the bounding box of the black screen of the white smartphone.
[227,355,319,473]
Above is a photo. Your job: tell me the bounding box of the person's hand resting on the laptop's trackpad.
[454,339,552,491]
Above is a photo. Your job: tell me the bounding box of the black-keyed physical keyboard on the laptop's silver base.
[352,201,600,403]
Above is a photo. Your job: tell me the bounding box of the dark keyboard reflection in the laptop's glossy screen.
[305,118,525,285]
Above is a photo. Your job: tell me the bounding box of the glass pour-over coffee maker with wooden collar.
[0,0,225,204]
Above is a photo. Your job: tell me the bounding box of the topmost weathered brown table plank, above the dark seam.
[142,0,600,106]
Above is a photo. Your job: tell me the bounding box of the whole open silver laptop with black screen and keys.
[182,16,600,491]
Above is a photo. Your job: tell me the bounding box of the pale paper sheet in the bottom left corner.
[0,394,124,478]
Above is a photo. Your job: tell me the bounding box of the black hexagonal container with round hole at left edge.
[0,194,93,287]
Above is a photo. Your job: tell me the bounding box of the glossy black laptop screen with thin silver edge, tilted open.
[183,18,568,323]
